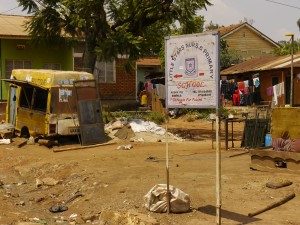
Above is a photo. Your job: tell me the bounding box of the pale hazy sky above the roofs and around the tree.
[0,0,300,41]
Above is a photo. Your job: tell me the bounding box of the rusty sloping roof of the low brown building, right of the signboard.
[221,53,300,75]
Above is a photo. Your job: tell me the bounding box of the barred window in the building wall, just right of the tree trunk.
[94,60,116,83]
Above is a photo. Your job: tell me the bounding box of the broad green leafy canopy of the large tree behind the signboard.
[18,0,211,69]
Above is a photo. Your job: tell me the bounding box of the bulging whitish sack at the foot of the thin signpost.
[144,184,191,213]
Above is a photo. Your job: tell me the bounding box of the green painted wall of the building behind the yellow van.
[0,39,74,100]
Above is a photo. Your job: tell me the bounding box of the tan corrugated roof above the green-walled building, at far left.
[0,14,30,38]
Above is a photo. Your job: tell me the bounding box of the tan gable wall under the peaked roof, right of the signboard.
[222,27,275,59]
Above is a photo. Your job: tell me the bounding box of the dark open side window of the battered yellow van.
[20,86,48,112]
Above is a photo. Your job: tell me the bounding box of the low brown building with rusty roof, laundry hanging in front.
[221,54,300,106]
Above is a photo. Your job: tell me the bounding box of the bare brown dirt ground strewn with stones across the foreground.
[0,120,300,225]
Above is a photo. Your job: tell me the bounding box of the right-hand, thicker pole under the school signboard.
[216,107,220,225]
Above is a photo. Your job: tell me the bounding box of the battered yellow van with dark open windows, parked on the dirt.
[5,69,94,136]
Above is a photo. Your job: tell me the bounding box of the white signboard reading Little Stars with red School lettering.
[165,33,219,108]
